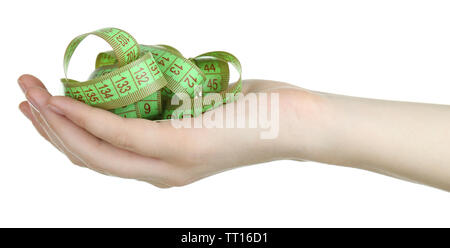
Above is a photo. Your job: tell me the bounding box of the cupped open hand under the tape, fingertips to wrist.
[19,75,322,188]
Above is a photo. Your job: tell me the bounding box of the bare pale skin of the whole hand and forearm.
[18,75,450,191]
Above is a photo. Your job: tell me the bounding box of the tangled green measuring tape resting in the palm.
[61,28,242,120]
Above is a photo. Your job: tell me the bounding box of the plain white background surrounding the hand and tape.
[0,0,450,227]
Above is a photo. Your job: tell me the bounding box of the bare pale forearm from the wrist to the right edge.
[288,93,450,190]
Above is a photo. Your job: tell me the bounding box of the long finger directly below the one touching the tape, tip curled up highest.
[27,87,172,182]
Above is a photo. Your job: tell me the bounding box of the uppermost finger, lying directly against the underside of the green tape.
[49,96,196,158]
